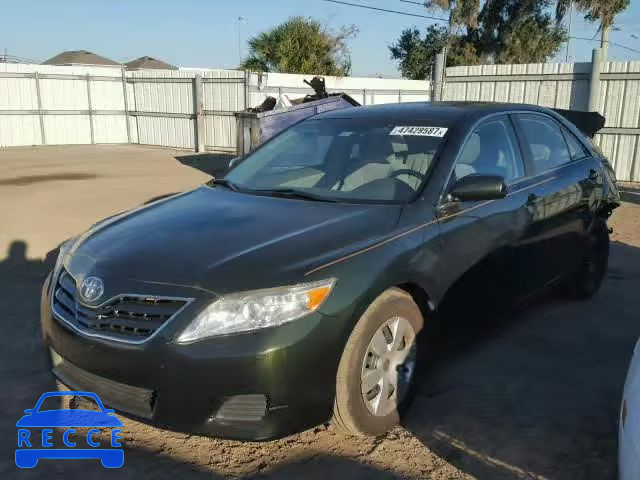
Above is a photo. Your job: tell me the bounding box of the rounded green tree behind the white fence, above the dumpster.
[240,17,357,76]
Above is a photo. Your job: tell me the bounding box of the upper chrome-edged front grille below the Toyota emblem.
[51,268,189,343]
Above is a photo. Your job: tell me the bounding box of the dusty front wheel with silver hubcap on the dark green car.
[332,288,424,436]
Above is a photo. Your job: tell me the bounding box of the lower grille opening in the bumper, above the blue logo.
[53,357,155,419]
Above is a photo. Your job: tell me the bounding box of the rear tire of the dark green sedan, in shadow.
[564,219,609,300]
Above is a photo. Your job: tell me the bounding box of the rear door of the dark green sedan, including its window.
[513,113,601,282]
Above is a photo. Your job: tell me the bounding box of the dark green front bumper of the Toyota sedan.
[41,274,351,440]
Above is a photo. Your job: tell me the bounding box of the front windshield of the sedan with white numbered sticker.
[222,119,447,202]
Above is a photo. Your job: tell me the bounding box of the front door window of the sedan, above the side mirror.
[454,117,524,183]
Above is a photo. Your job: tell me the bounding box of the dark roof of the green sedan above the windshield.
[312,102,550,124]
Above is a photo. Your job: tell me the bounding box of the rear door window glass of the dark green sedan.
[516,114,571,175]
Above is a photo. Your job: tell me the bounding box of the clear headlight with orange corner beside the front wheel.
[178,278,335,343]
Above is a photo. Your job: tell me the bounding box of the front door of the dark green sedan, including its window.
[437,115,542,300]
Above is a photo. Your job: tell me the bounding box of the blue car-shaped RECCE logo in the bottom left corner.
[16,391,124,468]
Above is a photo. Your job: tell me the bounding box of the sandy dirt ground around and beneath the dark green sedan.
[0,146,640,480]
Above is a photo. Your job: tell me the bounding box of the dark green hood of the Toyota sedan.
[68,186,401,293]
